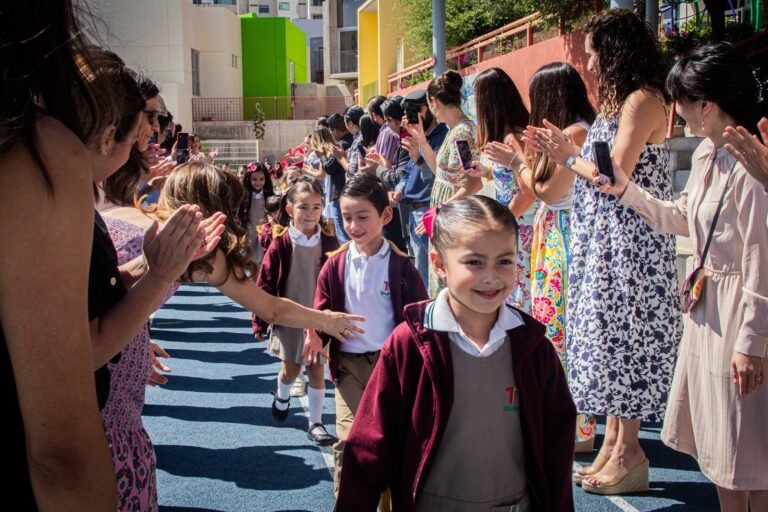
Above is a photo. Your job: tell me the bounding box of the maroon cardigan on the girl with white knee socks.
[251,228,339,338]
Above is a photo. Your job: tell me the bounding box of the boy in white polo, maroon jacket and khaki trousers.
[308,174,427,501]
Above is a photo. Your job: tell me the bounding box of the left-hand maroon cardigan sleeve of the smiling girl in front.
[335,330,409,512]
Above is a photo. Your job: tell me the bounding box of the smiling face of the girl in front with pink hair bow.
[431,230,517,318]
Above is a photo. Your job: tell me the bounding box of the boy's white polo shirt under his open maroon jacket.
[341,240,395,354]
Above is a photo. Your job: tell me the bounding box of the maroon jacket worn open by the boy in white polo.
[315,242,428,379]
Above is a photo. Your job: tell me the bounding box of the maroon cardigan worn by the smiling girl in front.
[336,302,576,512]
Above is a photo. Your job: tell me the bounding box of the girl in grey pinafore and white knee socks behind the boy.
[254,177,339,445]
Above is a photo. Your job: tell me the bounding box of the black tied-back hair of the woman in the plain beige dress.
[667,43,767,134]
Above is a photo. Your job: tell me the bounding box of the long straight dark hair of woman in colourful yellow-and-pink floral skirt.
[525,62,595,193]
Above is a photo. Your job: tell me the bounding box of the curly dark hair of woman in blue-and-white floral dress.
[584,9,669,115]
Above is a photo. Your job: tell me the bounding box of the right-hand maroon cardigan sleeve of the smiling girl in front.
[536,340,576,512]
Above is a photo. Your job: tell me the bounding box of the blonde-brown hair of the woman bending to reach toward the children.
[147,161,258,281]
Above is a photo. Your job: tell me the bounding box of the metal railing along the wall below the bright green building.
[192,96,353,123]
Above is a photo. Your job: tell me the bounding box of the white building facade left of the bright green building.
[91,0,243,130]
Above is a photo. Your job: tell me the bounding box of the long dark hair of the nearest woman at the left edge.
[0,0,118,192]
